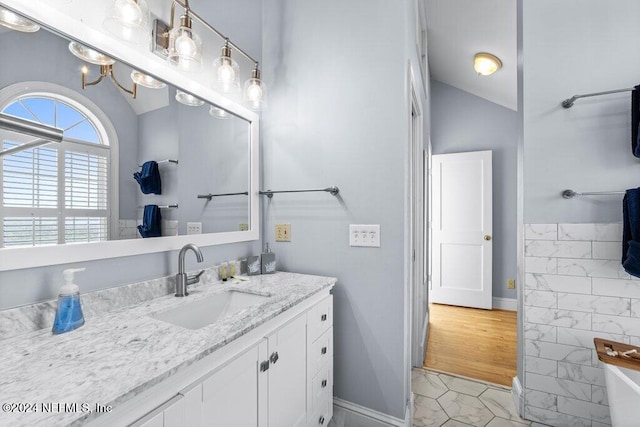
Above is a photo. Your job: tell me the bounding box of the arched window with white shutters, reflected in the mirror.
[0,82,117,247]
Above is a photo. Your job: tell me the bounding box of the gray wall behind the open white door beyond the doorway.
[431,81,518,299]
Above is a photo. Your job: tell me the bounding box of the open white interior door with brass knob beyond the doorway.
[430,151,492,309]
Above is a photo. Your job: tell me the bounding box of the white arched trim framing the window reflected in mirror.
[0,81,120,246]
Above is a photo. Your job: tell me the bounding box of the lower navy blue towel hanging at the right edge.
[622,188,640,277]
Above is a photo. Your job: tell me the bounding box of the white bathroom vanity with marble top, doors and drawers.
[0,273,336,427]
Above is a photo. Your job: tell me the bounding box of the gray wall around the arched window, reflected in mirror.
[0,30,138,218]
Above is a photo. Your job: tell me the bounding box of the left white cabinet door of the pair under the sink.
[202,346,262,427]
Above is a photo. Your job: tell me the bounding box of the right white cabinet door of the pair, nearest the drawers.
[267,315,307,427]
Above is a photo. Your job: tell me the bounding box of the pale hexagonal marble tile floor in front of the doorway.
[411,369,542,427]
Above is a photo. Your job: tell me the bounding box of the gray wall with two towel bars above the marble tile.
[522,0,640,223]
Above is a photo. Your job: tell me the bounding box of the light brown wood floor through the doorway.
[424,304,517,387]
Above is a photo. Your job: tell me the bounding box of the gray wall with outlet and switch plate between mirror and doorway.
[262,0,417,418]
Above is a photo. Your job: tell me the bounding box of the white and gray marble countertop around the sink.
[0,272,336,426]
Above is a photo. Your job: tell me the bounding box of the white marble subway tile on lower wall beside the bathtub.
[523,223,640,427]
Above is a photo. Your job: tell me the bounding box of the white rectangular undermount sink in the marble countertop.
[151,290,269,329]
